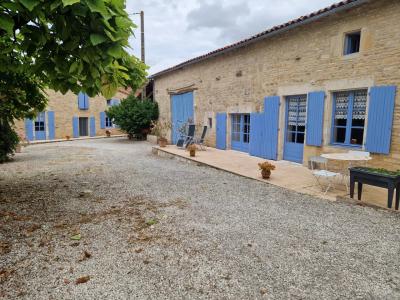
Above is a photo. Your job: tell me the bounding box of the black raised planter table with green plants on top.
[350,167,400,210]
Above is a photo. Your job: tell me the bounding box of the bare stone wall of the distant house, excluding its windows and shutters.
[15,90,127,139]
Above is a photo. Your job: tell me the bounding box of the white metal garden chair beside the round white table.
[309,156,340,195]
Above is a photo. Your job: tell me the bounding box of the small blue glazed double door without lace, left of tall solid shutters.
[231,114,250,152]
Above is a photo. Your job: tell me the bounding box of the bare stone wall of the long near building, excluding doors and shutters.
[154,0,400,169]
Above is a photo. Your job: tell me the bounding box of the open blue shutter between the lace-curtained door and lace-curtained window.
[306,91,325,146]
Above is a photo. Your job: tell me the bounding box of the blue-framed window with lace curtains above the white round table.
[332,90,368,146]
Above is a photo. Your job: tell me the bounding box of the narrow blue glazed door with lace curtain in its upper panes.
[283,95,307,163]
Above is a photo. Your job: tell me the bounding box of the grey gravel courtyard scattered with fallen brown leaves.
[0,138,400,299]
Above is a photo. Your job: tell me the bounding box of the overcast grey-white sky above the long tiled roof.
[126,0,339,74]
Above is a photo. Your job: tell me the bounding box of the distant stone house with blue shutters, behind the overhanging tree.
[15,89,129,141]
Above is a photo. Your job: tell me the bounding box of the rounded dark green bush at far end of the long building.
[107,94,158,135]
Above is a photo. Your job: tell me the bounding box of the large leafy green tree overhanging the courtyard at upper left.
[0,0,146,159]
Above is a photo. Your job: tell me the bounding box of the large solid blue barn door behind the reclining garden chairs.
[171,92,194,144]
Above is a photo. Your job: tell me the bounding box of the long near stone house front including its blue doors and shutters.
[151,0,400,169]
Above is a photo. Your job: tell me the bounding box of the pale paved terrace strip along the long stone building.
[153,145,394,208]
